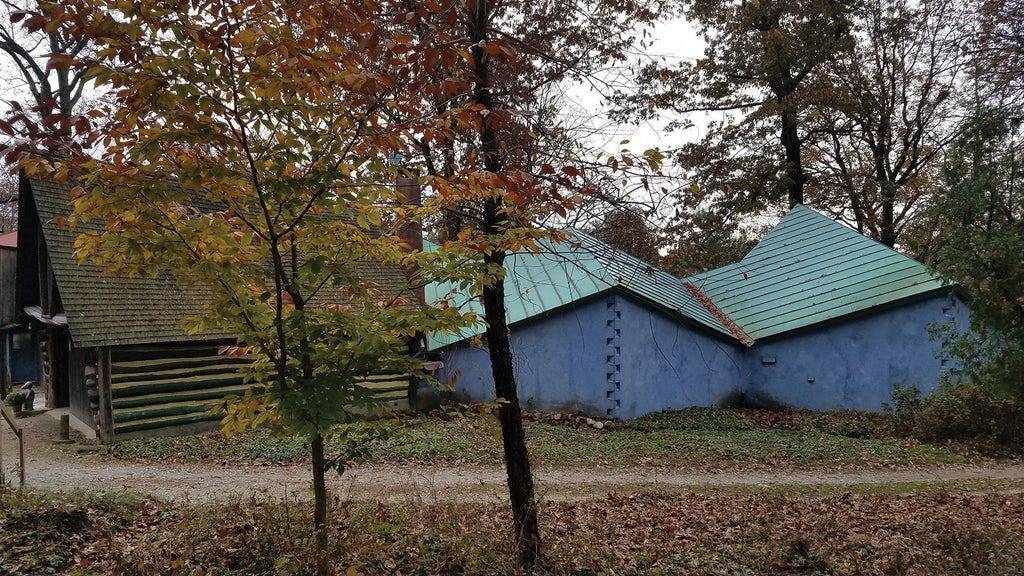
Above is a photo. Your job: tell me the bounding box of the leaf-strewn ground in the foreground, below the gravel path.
[14,483,1024,576]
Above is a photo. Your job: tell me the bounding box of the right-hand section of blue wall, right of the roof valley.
[745,295,969,411]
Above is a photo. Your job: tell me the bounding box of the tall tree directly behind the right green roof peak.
[611,0,857,272]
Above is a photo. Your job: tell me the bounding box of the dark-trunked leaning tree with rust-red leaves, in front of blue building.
[395,0,653,570]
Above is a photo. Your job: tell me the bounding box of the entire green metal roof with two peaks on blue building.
[427,206,948,347]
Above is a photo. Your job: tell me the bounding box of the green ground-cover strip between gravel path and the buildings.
[106,408,981,469]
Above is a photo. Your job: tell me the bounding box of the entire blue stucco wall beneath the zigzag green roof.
[437,294,969,419]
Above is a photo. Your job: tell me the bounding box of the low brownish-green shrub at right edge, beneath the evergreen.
[885,381,1024,451]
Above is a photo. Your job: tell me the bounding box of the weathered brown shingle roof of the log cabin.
[28,178,407,346]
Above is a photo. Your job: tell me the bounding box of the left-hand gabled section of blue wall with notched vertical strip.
[437,293,743,418]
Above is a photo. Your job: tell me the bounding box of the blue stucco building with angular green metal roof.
[428,206,968,418]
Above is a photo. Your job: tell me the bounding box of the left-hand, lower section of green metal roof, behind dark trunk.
[426,230,731,348]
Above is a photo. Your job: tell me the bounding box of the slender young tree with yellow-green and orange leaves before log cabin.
[2,0,476,574]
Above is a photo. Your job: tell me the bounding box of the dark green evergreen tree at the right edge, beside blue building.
[930,109,1024,398]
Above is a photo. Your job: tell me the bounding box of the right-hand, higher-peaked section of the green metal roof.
[684,201,945,339]
